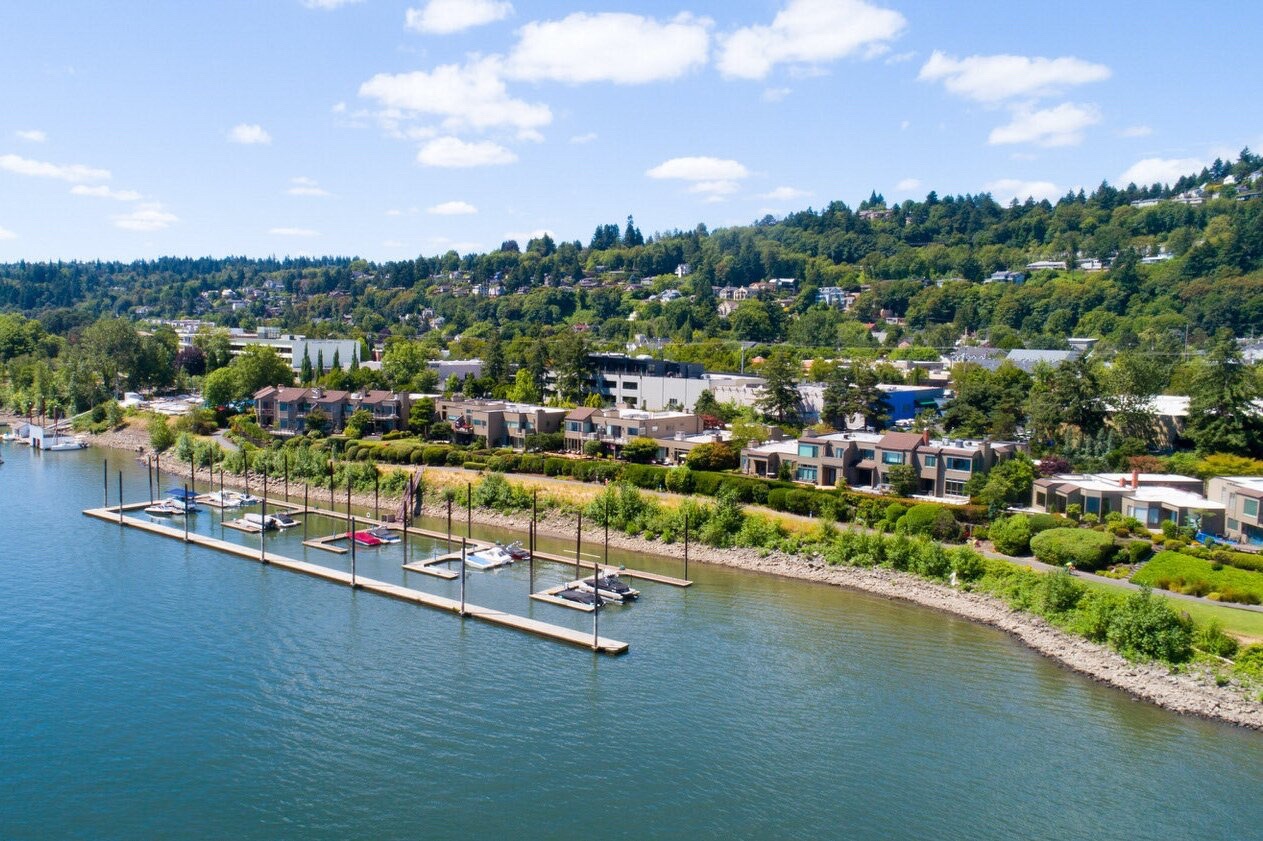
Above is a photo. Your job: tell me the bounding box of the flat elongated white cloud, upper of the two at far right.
[917,49,1110,104]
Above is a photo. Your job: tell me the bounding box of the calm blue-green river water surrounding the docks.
[0,446,1263,841]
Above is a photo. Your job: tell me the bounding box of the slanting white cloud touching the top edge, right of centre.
[719,0,908,78]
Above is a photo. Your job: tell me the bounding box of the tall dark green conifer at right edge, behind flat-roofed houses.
[1186,328,1263,457]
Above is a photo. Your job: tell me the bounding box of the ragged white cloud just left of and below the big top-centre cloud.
[360,57,552,131]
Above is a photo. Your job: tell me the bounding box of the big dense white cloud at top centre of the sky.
[506,11,710,85]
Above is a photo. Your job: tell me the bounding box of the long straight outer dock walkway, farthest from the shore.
[83,503,629,654]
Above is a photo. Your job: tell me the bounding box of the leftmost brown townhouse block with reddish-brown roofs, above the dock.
[254,385,412,434]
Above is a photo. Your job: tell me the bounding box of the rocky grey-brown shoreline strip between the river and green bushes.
[14,418,1263,731]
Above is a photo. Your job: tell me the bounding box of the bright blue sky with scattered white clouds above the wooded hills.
[0,0,1263,260]
